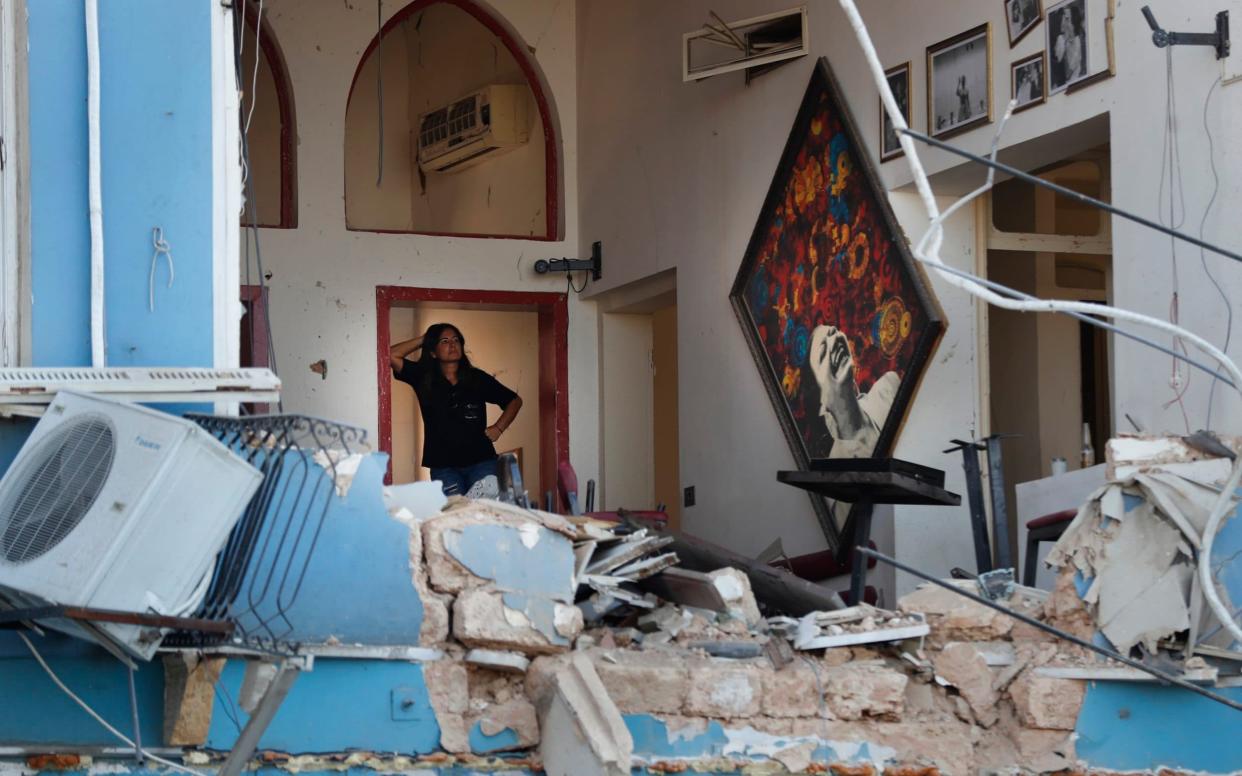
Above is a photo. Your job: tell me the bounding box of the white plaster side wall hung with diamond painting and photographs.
[579,0,1242,589]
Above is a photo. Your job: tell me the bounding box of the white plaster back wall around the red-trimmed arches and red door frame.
[247,0,599,479]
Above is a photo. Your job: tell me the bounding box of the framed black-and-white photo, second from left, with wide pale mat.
[928,24,992,138]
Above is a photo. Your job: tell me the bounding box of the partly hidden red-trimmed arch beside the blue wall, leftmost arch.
[237,2,298,228]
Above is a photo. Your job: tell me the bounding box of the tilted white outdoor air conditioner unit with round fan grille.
[0,391,262,659]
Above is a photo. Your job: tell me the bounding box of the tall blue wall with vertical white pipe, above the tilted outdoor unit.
[26,0,214,366]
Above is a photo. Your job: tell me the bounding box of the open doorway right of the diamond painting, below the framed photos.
[986,147,1114,578]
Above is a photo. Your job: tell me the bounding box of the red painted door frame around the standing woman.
[375,286,569,505]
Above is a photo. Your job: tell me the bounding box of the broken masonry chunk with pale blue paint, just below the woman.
[422,502,575,595]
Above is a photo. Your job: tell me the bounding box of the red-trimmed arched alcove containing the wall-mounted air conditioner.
[344,0,560,240]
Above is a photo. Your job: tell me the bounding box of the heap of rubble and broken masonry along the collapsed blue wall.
[394,499,1117,776]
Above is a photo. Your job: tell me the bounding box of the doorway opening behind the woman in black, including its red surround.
[375,286,569,499]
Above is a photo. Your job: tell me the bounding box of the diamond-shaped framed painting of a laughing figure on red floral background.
[729,57,945,545]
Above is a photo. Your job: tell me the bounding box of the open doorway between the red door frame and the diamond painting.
[596,274,682,529]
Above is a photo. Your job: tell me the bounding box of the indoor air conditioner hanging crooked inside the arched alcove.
[416,83,530,173]
